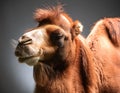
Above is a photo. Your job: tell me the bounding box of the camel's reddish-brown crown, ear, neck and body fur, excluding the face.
[16,6,120,93]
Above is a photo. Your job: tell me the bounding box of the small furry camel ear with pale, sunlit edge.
[71,20,83,38]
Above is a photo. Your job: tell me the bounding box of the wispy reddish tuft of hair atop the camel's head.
[34,5,64,22]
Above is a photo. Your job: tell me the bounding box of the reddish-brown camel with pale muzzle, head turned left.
[15,5,120,93]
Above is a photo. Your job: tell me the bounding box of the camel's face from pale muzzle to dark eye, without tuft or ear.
[15,25,68,65]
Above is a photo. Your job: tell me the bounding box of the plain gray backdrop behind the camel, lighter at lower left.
[0,0,120,93]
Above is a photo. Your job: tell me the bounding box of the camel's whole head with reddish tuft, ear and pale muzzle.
[15,5,82,66]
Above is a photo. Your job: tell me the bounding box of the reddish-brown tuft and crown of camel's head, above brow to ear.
[34,4,73,31]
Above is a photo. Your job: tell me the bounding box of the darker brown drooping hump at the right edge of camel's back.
[104,18,120,47]
